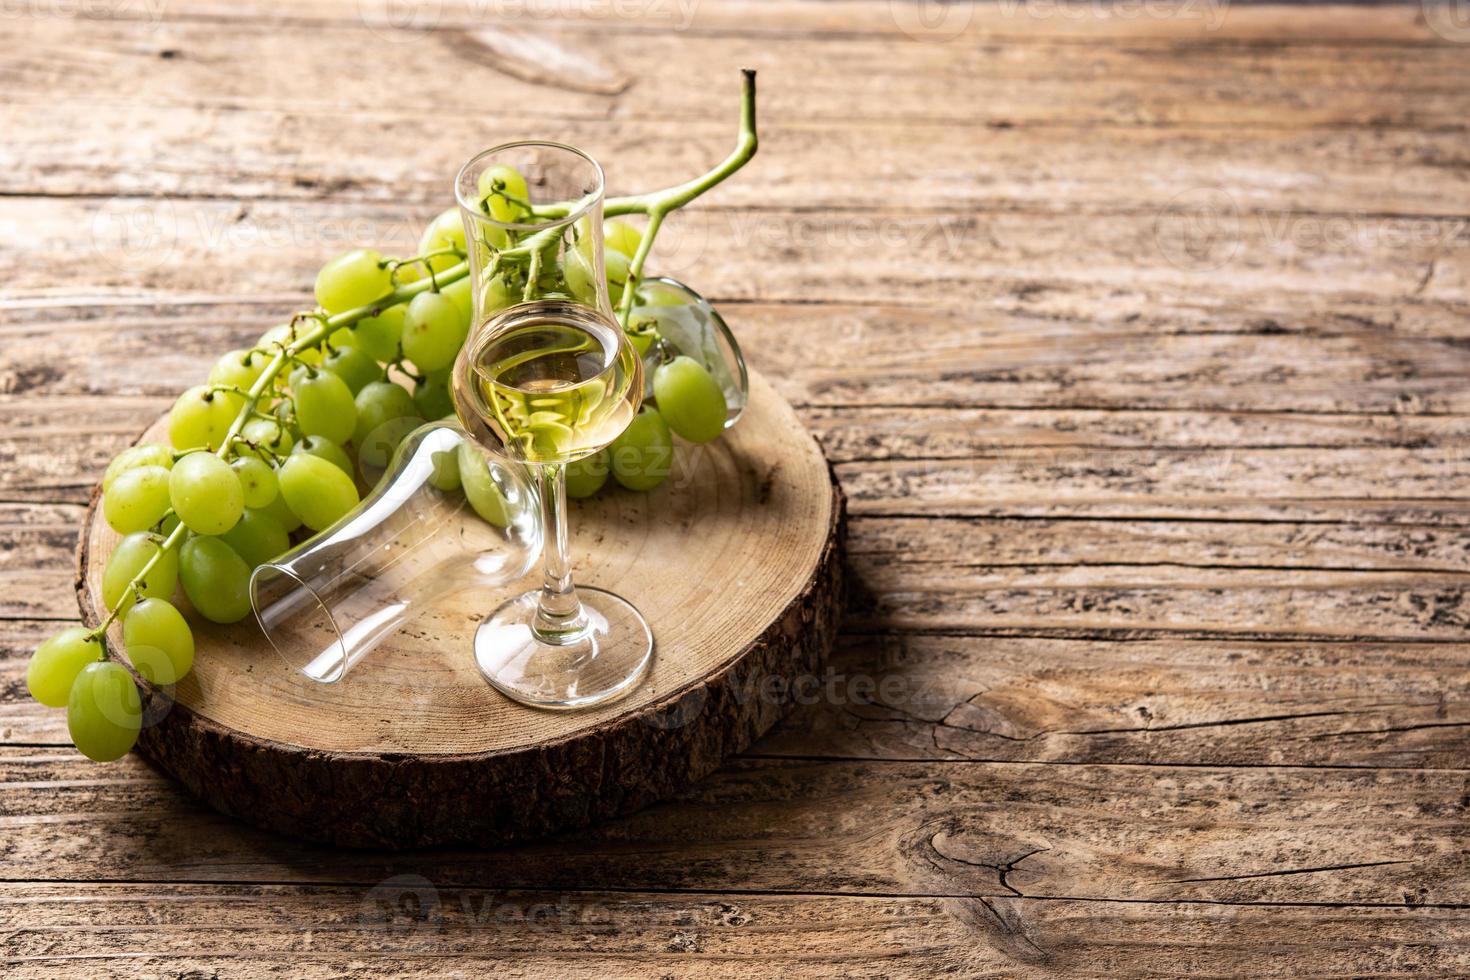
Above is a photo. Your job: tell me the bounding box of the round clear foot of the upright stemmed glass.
[475,586,653,710]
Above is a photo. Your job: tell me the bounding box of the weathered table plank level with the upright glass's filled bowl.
[14,302,1470,417]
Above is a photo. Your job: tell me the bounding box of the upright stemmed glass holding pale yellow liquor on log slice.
[453,143,653,708]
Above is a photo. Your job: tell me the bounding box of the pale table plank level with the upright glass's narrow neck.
[0,198,1470,321]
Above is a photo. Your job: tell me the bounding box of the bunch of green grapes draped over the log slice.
[37,169,726,761]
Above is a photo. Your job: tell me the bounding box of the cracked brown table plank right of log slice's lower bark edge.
[754,633,1470,768]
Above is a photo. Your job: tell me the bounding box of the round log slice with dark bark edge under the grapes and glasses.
[76,375,844,848]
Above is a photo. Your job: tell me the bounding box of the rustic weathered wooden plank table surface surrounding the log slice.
[0,0,1470,977]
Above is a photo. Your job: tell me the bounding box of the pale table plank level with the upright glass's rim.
[11,105,1466,220]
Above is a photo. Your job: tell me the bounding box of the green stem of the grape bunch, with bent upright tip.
[88,74,759,643]
